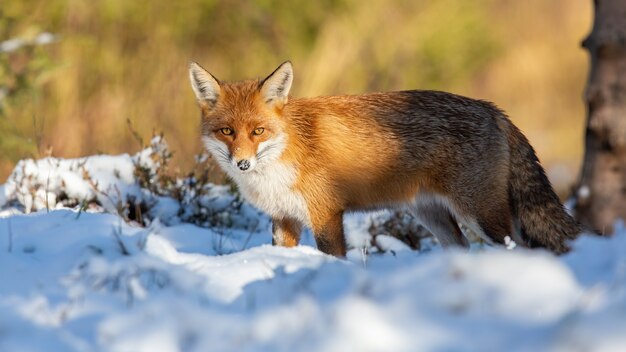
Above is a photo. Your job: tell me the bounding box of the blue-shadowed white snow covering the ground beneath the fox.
[0,144,626,352]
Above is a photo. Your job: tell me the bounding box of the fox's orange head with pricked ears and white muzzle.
[189,61,293,175]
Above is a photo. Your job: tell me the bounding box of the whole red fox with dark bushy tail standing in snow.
[189,61,581,256]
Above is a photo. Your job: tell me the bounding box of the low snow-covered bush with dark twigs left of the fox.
[0,135,262,231]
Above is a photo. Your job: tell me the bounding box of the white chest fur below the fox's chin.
[231,161,310,226]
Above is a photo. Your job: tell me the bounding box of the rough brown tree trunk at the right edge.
[574,0,626,234]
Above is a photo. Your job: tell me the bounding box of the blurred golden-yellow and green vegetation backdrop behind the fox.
[0,0,592,195]
